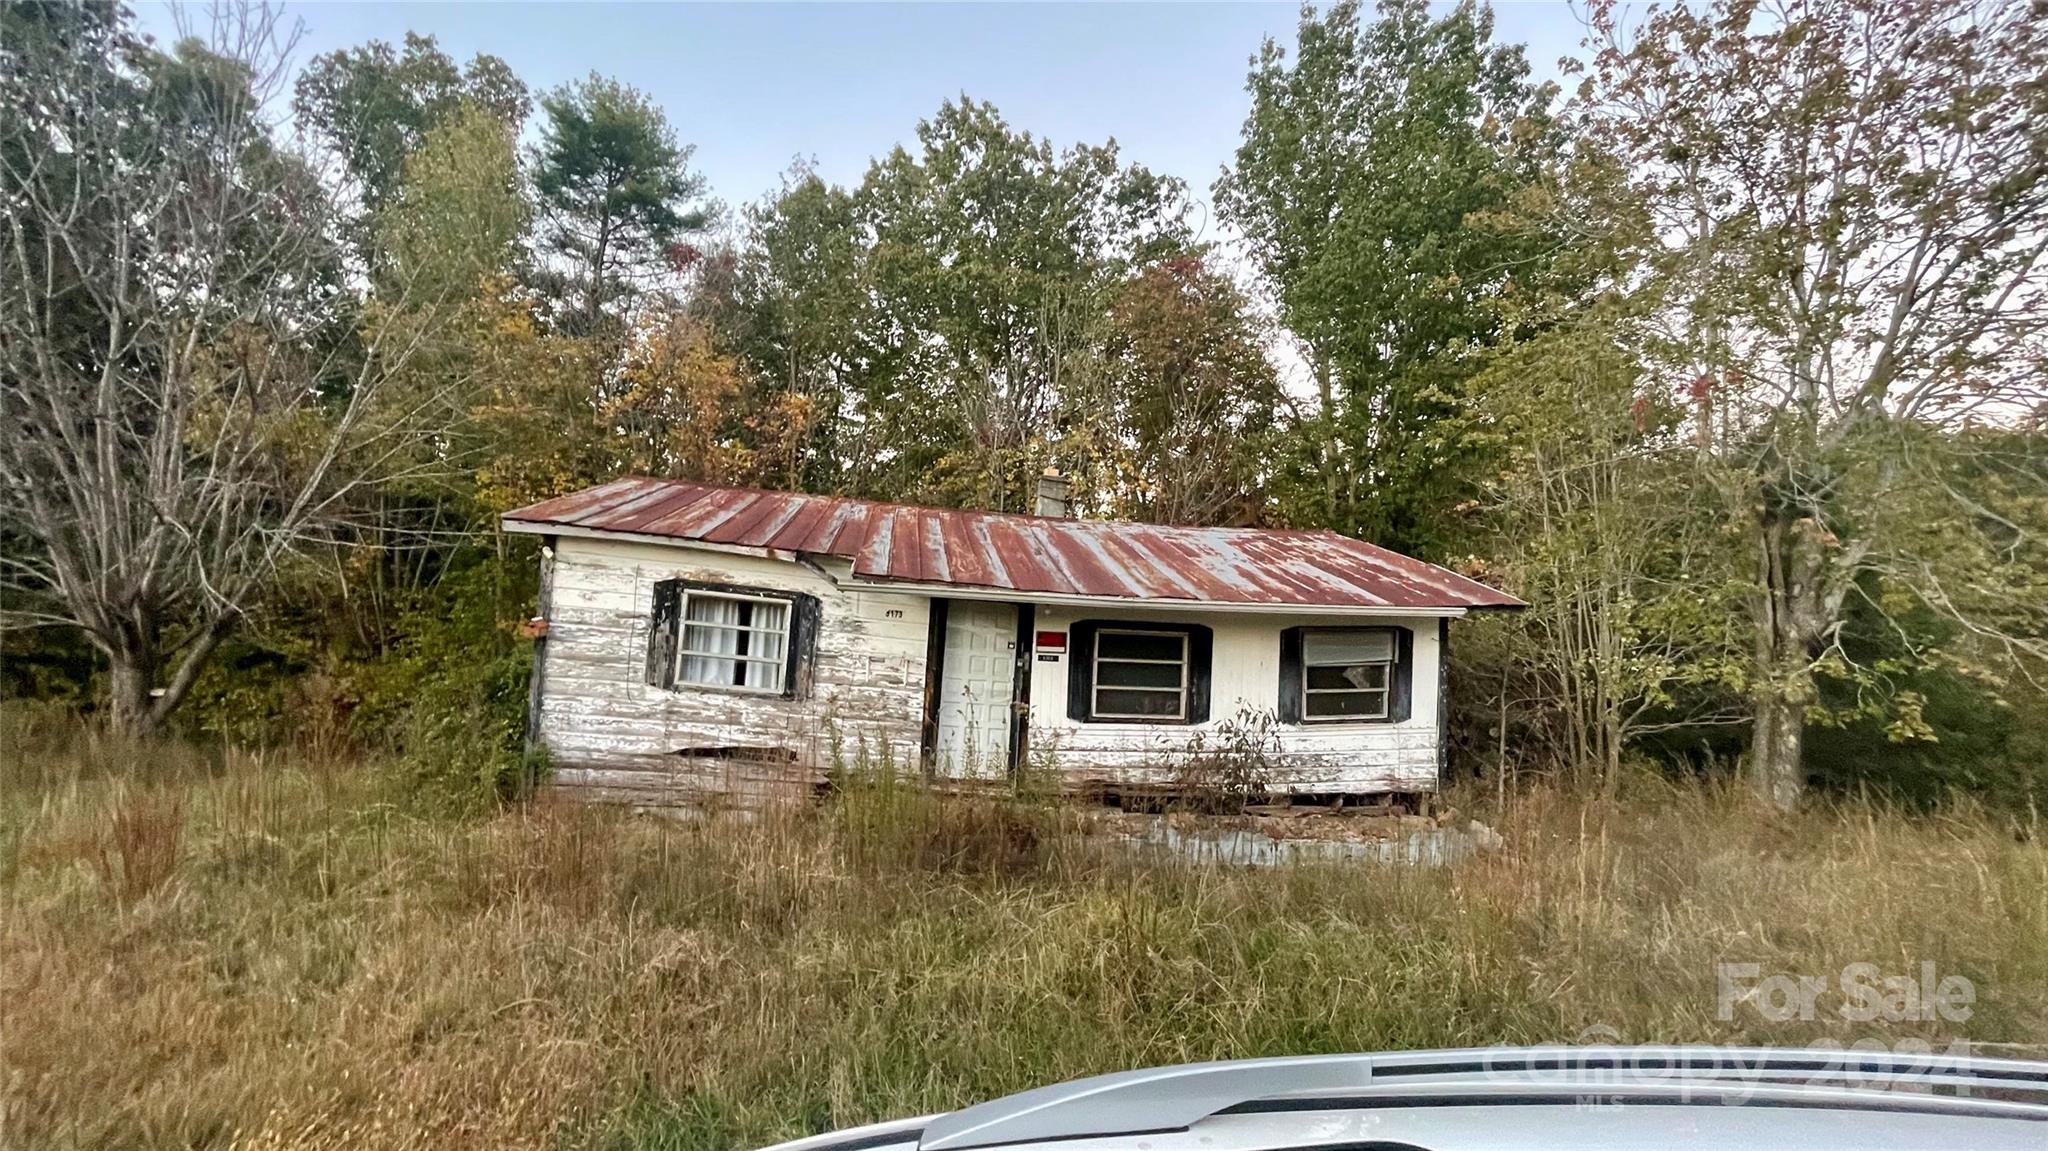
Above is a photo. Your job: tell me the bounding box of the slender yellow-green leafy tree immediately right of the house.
[1466,299,1747,791]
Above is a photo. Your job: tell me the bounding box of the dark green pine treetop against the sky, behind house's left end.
[532,74,711,336]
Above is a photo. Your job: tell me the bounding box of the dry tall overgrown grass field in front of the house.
[0,716,2048,1151]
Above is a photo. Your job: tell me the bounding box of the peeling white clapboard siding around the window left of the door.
[539,537,930,803]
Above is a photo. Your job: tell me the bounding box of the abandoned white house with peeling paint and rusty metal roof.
[504,477,1522,805]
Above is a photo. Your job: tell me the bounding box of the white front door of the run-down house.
[934,600,1018,778]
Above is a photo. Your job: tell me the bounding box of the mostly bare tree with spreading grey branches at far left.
[0,4,471,731]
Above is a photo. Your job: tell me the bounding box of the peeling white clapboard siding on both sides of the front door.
[535,537,1442,807]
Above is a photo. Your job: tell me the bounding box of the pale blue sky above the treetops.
[137,2,1581,235]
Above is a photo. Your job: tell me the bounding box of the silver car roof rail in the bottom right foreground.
[920,1047,2048,1151]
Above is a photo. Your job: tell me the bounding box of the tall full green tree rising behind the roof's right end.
[1217,0,1556,553]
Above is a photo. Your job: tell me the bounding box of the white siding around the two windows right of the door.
[1030,606,1442,793]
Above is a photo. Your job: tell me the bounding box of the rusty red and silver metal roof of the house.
[504,477,1524,610]
